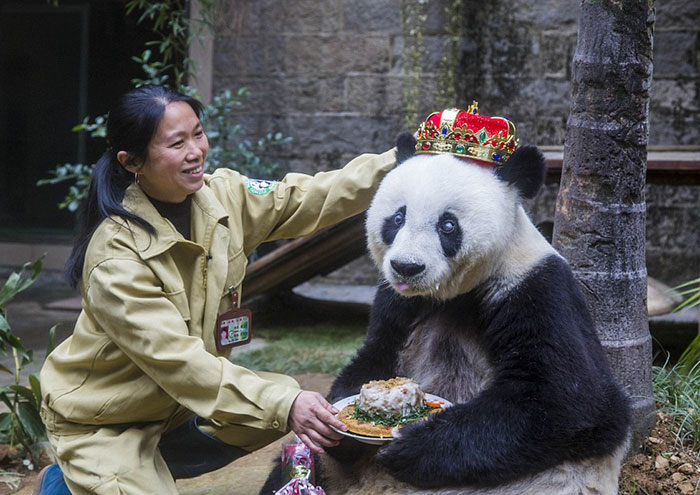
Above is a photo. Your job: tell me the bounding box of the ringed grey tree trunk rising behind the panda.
[554,0,654,447]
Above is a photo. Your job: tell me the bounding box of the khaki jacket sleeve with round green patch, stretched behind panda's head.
[210,149,396,254]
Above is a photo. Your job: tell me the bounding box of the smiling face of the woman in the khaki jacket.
[131,101,209,203]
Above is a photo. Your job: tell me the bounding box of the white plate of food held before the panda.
[333,377,452,445]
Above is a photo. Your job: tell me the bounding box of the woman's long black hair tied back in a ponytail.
[66,86,204,288]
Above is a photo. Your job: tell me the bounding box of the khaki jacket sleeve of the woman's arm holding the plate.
[85,256,300,431]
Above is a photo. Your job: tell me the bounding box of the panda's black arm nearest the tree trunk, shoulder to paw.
[378,259,629,487]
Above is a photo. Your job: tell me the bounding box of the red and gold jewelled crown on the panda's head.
[416,101,518,166]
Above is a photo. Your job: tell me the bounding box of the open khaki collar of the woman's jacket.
[122,183,228,259]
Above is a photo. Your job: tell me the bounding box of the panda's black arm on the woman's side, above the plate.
[328,285,420,402]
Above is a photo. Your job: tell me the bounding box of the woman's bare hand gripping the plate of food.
[288,390,347,454]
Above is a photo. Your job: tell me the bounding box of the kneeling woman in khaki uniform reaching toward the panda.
[38,86,395,495]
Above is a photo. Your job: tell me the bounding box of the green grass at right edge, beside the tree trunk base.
[652,363,700,450]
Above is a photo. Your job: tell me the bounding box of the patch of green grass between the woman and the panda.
[231,324,366,375]
